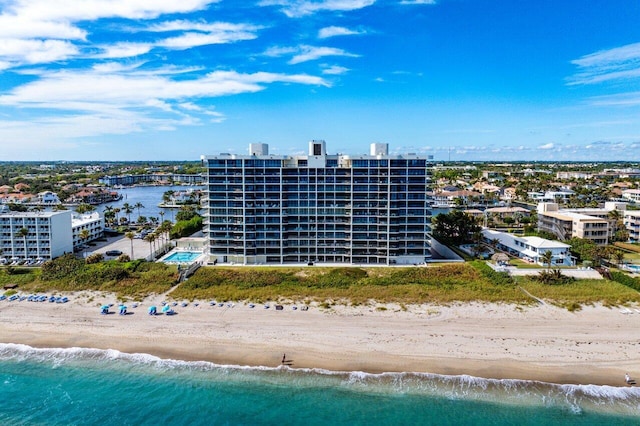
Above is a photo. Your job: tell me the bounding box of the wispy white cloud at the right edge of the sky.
[568,43,640,85]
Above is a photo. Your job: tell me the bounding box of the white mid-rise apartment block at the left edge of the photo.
[0,211,73,263]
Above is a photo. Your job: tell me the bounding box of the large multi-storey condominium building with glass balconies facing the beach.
[203,141,431,265]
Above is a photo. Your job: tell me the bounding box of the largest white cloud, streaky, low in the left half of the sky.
[0,63,329,146]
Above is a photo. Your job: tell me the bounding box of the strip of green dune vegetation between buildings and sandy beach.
[0,256,640,310]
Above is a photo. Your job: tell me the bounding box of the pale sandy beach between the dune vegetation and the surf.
[0,293,640,386]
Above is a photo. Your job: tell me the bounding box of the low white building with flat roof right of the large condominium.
[482,229,574,266]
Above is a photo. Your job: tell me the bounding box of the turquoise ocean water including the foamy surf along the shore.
[0,341,640,426]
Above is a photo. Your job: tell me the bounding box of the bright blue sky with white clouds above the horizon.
[0,0,640,161]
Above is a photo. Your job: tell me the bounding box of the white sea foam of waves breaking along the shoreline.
[0,343,640,415]
